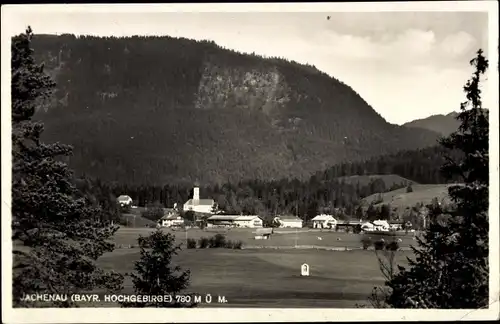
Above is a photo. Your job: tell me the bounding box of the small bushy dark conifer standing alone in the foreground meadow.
[122,229,194,307]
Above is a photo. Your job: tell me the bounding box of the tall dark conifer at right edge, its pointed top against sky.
[380,50,489,309]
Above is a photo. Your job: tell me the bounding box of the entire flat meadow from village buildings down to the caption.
[92,228,415,308]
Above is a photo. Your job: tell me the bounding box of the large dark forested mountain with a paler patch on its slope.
[32,35,438,184]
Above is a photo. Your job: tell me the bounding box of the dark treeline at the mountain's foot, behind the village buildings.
[79,147,456,220]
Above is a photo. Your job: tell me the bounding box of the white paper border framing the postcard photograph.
[1,1,500,323]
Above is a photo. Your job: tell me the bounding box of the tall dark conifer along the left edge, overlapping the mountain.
[11,27,123,307]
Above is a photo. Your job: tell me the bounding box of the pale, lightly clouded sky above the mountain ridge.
[1,4,498,124]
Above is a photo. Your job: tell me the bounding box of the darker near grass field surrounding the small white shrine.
[95,249,407,308]
